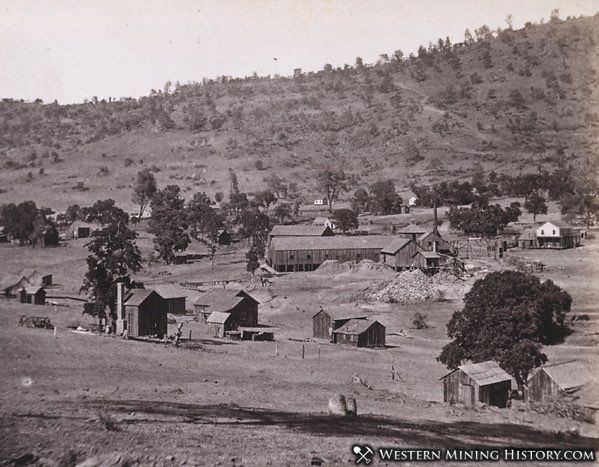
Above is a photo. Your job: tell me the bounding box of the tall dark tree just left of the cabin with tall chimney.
[83,221,141,330]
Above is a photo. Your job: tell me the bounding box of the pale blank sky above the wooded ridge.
[0,0,599,103]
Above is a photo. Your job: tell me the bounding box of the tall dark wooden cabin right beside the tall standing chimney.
[124,289,167,338]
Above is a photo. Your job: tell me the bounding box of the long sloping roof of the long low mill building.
[271,235,392,251]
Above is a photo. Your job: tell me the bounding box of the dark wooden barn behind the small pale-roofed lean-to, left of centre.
[193,289,259,326]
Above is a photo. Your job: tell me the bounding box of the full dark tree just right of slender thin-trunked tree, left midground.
[149,185,189,264]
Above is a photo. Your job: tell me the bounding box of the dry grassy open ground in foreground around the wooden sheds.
[0,241,599,466]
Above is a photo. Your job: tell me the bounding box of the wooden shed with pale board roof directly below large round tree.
[441,361,512,407]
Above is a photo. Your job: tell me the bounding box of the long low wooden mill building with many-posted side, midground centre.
[266,235,392,272]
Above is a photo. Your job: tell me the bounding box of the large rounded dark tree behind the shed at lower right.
[438,271,572,387]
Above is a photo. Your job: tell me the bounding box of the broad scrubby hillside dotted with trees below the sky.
[0,15,599,209]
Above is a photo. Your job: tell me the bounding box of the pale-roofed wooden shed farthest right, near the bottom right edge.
[525,360,590,403]
